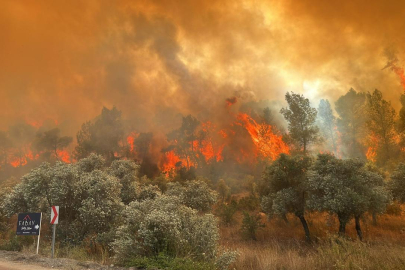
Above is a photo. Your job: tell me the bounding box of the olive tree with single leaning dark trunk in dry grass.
[262,154,311,241]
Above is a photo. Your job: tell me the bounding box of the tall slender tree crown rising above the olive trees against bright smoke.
[280,92,319,154]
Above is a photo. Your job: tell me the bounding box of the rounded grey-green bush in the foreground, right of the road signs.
[113,195,219,261]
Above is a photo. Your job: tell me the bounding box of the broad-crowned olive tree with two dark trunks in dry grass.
[308,154,389,240]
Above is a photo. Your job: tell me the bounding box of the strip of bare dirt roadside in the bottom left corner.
[0,250,130,270]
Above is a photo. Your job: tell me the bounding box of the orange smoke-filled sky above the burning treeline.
[0,0,405,135]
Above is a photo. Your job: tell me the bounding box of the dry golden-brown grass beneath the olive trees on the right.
[221,213,405,270]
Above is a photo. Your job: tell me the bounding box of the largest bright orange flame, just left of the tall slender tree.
[237,113,290,160]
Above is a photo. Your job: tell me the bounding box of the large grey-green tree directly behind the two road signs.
[2,155,123,243]
